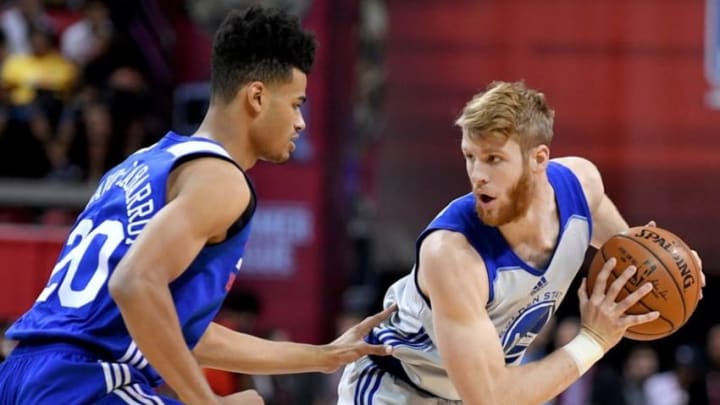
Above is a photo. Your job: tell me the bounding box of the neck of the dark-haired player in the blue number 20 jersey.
[193,104,258,170]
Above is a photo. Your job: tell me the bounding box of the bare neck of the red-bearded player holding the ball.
[499,175,560,249]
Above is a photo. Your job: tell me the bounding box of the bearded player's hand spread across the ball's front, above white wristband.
[578,258,660,352]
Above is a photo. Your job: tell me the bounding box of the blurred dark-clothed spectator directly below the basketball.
[622,344,658,405]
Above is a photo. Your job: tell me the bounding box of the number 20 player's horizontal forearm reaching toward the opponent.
[193,323,331,374]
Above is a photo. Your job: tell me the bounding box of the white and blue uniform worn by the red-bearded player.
[338,162,592,405]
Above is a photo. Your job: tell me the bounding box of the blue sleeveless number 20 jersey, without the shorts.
[6,132,256,384]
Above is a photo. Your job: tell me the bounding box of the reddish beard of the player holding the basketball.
[475,168,535,227]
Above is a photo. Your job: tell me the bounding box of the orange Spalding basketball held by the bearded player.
[587,226,702,340]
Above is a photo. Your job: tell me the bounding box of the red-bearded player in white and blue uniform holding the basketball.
[338,82,699,405]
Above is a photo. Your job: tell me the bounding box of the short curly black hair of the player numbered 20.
[211,6,317,102]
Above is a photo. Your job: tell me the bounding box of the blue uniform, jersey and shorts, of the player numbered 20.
[0,132,256,404]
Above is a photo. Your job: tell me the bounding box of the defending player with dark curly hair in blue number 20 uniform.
[0,8,392,405]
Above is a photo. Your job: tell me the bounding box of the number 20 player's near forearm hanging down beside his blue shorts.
[112,282,217,404]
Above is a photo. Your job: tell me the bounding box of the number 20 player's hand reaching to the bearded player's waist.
[323,304,397,373]
